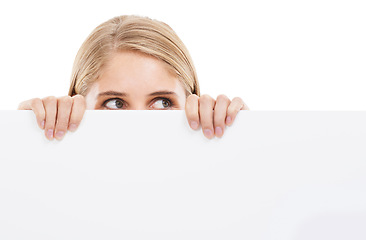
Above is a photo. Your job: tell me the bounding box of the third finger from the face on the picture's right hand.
[214,95,231,137]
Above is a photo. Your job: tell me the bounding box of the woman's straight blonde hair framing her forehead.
[69,15,200,96]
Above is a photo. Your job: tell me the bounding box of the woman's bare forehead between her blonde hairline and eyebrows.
[85,51,185,96]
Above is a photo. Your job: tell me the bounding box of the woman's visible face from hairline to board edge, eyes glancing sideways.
[85,50,187,110]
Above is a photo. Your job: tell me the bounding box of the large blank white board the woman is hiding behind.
[0,111,366,240]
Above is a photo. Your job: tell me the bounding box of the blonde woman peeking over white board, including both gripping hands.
[18,16,249,140]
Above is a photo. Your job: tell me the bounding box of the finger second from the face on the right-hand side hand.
[199,94,215,139]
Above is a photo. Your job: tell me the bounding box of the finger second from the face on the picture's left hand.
[55,96,72,140]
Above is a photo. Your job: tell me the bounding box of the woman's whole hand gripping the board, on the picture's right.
[185,94,249,139]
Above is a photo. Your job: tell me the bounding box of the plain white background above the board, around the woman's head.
[0,0,366,110]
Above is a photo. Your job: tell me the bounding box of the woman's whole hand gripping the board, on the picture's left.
[18,95,86,140]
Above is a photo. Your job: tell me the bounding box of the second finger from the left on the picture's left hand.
[43,97,57,140]
